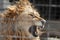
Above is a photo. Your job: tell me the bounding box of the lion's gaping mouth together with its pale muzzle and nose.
[29,21,46,37]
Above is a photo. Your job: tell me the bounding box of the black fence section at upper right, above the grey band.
[32,0,60,20]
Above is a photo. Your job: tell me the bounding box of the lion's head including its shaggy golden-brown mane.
[0,0,46,40]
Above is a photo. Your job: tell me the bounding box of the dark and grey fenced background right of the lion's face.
[33,0,60,40]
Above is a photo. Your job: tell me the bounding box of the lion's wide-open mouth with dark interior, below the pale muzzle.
[29,25,44,37]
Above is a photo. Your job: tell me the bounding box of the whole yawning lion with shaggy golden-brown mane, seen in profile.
[0,0,46,40]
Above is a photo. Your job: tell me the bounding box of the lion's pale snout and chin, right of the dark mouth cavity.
[32,19,46,36]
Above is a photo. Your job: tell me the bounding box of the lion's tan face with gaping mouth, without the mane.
[17,7,46,36]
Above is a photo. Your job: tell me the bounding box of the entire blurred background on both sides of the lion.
[0,0,60,40]
